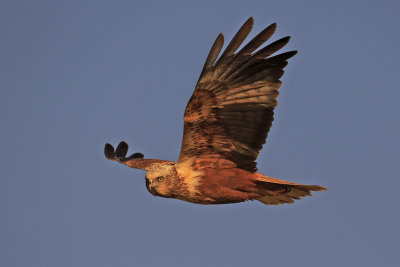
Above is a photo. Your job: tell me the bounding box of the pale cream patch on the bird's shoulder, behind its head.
[175,160,204,196]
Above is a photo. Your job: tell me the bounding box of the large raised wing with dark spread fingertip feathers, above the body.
[178,17,297,172]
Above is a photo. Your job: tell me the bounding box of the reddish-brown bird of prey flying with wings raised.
[104,17,326,205]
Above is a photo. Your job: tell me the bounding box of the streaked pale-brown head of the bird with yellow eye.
[146,162,177,197]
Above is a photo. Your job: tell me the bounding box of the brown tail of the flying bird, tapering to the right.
[257,174,328,205]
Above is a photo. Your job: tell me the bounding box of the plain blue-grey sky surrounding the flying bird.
[0,0,400,267]
